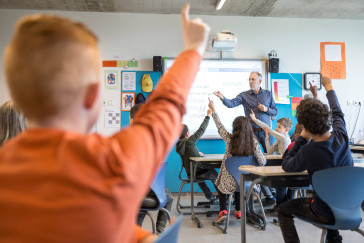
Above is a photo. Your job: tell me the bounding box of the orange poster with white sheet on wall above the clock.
[320,42,346,79]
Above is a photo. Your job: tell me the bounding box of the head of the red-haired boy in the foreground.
[5,15,100,132]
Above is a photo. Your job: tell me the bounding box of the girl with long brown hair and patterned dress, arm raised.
[209,100,266,223]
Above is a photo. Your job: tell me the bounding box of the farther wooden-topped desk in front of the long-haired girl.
[190,154,282,228]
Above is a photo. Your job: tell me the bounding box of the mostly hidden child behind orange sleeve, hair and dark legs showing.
[129,103,173,234]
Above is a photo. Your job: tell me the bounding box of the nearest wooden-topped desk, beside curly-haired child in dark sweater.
[239,166,310,243]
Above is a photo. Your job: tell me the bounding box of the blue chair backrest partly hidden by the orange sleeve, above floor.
[150,162,168,210]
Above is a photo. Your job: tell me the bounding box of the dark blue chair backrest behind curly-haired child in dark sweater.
[312,166,364,230]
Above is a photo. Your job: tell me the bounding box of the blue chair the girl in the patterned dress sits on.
[212,156,265,234]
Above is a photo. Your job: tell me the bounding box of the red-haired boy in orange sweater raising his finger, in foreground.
[0,4,209,242]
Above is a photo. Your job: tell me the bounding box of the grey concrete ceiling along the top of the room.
[0,0,364,19]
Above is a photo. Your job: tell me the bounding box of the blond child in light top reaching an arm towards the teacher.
[250,110,292,154]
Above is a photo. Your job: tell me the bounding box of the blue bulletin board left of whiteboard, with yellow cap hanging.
[120,71,162,128]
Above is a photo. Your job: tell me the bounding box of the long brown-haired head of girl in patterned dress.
[230,116,255,156]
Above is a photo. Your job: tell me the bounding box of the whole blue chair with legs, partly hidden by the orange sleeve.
[140,162,171,234]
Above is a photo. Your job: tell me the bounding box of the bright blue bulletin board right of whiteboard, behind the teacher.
[270,73,302,135]
